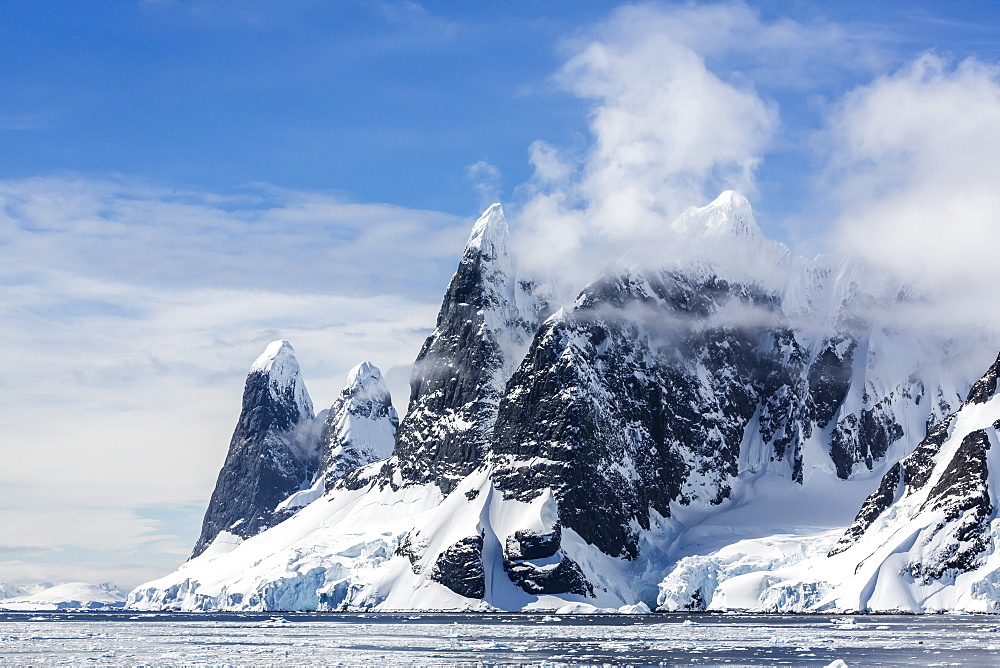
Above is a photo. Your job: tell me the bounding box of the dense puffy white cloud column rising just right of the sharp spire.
[518,5,778,294]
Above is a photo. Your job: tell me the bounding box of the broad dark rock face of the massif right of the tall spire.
[492,272,788,559]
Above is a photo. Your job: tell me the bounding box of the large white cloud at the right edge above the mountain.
[827,54,1000,324]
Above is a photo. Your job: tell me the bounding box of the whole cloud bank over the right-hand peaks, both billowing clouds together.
[508,3,1000,336]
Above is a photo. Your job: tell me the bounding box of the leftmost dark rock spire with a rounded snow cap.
[191,342,316,558]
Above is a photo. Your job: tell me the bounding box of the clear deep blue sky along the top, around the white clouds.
[0,0,1000,226]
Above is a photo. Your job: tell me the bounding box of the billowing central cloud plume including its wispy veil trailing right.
[504,2,891,296]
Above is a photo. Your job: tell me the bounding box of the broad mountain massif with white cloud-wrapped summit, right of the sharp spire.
[492,193,980,559]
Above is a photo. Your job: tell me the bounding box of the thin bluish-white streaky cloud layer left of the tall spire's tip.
[0,177,468,298]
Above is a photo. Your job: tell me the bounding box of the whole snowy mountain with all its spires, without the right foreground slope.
[129,192,1000,611]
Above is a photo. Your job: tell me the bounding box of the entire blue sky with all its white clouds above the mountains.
[0,0,1000,585]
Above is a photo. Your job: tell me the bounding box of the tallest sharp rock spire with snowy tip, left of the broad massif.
[383,205,548,494]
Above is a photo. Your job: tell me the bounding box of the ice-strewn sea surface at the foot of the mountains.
[0,611,1000,666]
